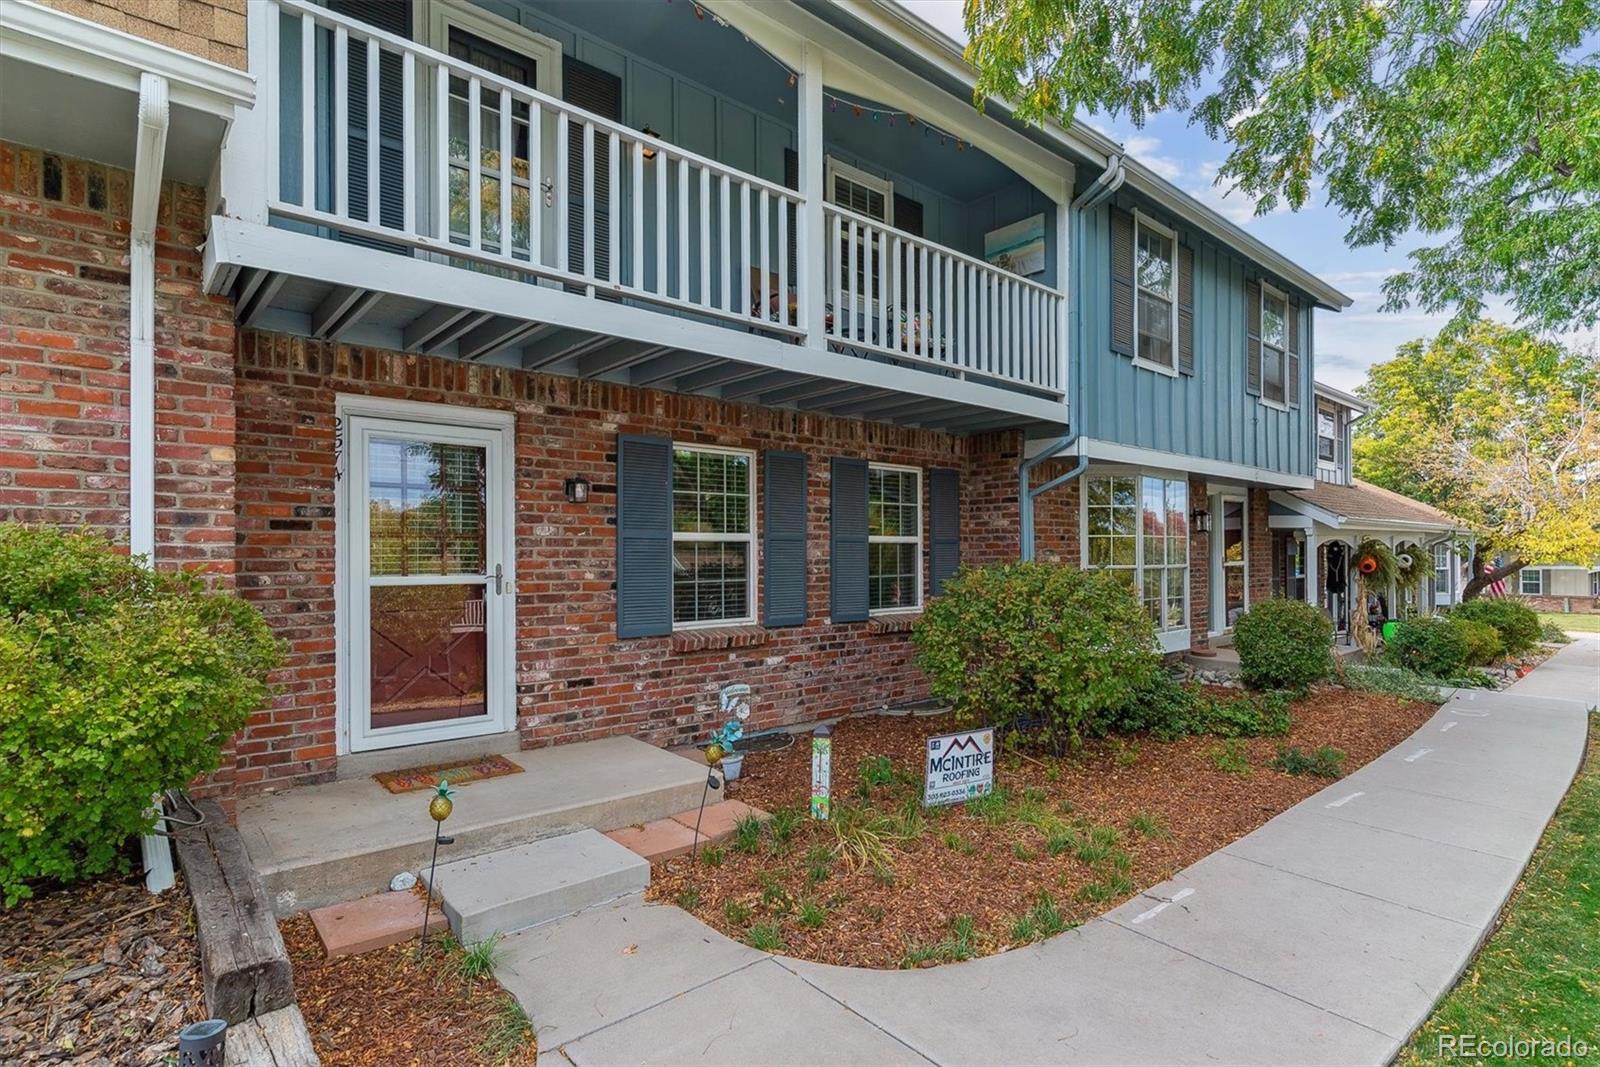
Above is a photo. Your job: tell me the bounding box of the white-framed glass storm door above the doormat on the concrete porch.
[339,406,515,752]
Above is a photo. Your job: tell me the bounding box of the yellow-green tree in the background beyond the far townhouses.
[1355,320,1600,598]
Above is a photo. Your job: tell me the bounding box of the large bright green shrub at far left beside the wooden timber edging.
[0,523,278,905]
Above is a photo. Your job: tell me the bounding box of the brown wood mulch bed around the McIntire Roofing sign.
[650,686,1435,968]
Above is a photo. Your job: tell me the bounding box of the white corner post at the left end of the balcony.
[208,3,282,226]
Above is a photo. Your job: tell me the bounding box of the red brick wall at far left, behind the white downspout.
[0,142,234,584]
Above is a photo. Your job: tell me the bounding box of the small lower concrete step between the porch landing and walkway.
[424,830,650,945]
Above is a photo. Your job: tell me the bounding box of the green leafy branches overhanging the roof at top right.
[966,0,1600,330]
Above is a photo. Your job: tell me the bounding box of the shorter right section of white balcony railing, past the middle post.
[822,205,1062,390]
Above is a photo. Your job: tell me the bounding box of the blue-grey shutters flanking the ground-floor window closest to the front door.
[616,434,812,638]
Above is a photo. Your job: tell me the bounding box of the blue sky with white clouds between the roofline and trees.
[899,0,1600,389]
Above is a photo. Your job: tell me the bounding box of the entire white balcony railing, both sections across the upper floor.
[258,0,1066,395]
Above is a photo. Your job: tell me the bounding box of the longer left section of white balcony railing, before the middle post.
[266,0,803,334]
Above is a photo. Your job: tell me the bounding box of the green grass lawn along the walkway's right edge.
[1398,713,1600,1064]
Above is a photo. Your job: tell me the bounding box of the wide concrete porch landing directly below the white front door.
[237,737,706,915]
